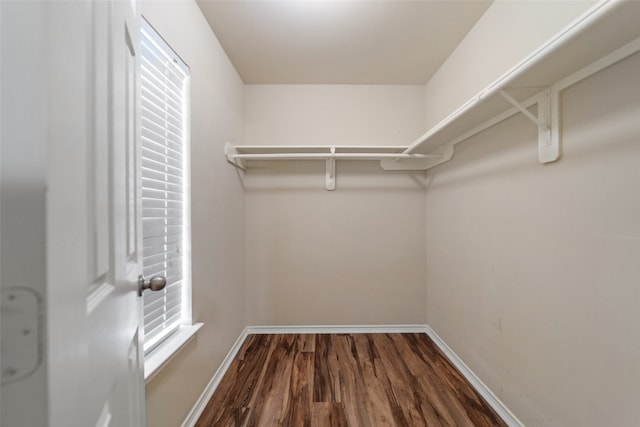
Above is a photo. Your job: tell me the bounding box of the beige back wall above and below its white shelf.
[245,86,426,325]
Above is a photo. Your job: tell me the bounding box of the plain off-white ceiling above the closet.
[197,0,491,84]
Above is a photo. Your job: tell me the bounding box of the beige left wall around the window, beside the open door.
[141,0,245,427]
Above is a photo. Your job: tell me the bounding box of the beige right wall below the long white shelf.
[427,48,640,426]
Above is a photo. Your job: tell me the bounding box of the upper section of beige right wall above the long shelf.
[425,0,597,128]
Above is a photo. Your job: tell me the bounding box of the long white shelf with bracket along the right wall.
[405,0,640,163]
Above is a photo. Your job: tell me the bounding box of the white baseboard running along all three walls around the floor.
[181,325,524,427]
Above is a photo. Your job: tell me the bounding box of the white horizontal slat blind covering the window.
[140,20,191,352]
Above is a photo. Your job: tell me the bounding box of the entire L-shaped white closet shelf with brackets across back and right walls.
[225,0,640,190]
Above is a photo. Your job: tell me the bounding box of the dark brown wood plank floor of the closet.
[196,334,506,427]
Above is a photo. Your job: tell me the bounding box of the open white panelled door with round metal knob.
[46,0,145,427]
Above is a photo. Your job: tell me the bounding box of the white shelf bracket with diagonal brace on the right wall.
[500,89,560,164]
